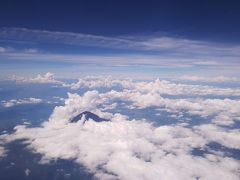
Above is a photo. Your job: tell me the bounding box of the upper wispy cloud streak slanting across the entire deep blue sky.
[0,28,240,56]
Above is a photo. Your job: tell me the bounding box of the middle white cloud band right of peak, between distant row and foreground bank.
[101,90,240,125]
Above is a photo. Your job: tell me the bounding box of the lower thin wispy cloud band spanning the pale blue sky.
[0,50,239,69]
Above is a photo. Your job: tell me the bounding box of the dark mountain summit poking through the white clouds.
[70,111,109,123]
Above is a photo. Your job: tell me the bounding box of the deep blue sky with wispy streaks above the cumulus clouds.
[0,0,240,78]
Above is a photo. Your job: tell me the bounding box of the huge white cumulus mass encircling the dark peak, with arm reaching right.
[3,91,240,179]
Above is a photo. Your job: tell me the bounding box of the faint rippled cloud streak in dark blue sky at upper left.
[0,28,134,48]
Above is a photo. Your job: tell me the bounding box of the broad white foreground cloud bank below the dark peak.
[5,114,239,179]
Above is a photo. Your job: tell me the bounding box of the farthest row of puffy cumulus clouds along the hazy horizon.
[11,72,240,96]
